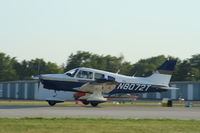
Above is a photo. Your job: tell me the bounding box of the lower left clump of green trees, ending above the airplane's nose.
[0,53,63,81]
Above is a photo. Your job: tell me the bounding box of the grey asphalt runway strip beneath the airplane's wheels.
[0,105,200,120]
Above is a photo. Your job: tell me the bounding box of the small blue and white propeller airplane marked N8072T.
[33,60,178,107]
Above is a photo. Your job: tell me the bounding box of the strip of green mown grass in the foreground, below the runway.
[0,118,200,133]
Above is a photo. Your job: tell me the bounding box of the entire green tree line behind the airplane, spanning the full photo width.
[0,51,200,81]
